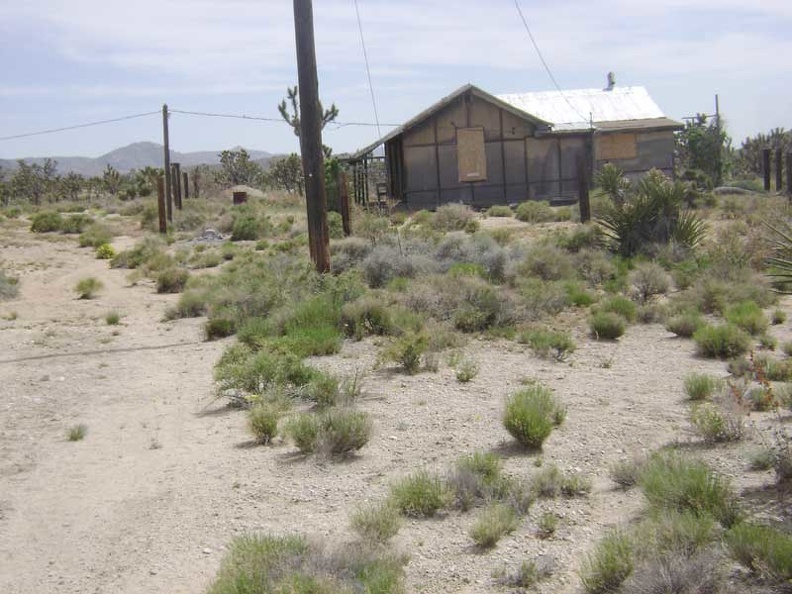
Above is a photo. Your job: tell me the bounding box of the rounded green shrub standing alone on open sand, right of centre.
[503,385,566,448]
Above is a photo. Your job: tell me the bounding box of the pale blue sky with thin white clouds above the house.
[0,0,792,158]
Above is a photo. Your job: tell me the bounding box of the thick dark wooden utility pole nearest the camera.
[294,0,330,272]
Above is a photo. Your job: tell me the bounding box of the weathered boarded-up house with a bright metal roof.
[347,84,683,209]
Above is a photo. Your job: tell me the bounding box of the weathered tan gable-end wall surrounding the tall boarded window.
[388,94,586,208]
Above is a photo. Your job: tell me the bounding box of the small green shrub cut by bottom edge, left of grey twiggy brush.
[578,532,634,594]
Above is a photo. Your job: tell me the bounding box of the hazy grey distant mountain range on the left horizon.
[0,142,274,177]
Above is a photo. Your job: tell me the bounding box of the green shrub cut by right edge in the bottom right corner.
[725,522,792,581]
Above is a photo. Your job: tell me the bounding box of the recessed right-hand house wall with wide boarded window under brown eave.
[594,130,674,177]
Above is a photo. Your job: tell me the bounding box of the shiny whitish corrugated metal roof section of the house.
[497,87,665,132]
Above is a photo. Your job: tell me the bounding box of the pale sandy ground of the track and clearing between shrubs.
[0,221,792,594]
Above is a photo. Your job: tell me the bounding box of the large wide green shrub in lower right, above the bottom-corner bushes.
[638,453,740,527]
